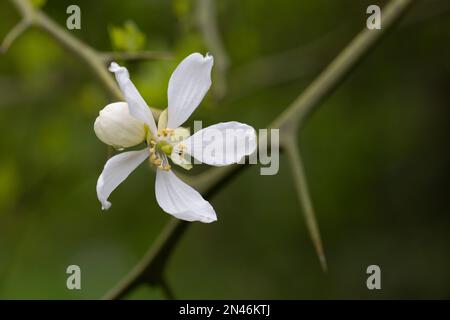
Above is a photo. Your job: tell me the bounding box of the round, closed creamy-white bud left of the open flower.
[94,102,146,149]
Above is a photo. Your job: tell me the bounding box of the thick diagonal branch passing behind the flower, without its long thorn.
[102,0,415,299]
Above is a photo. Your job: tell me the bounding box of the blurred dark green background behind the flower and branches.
[0,0,450,299]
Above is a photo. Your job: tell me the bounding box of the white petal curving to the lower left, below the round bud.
[97,149,149,210]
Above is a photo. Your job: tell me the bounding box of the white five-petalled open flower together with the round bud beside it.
[94,53,256,223]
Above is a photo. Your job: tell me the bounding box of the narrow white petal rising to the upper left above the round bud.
[109,62,156,135]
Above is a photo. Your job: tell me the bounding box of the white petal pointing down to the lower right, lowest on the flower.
[155,169,217,223]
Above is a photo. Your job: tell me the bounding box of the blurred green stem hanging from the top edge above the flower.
[196,0,230,99]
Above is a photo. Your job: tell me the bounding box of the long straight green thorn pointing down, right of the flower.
[284,137,327,272]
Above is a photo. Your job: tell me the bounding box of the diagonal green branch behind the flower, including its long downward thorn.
[105,0,415,299]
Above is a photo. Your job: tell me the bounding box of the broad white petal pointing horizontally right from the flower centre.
[180,121,256,166]
